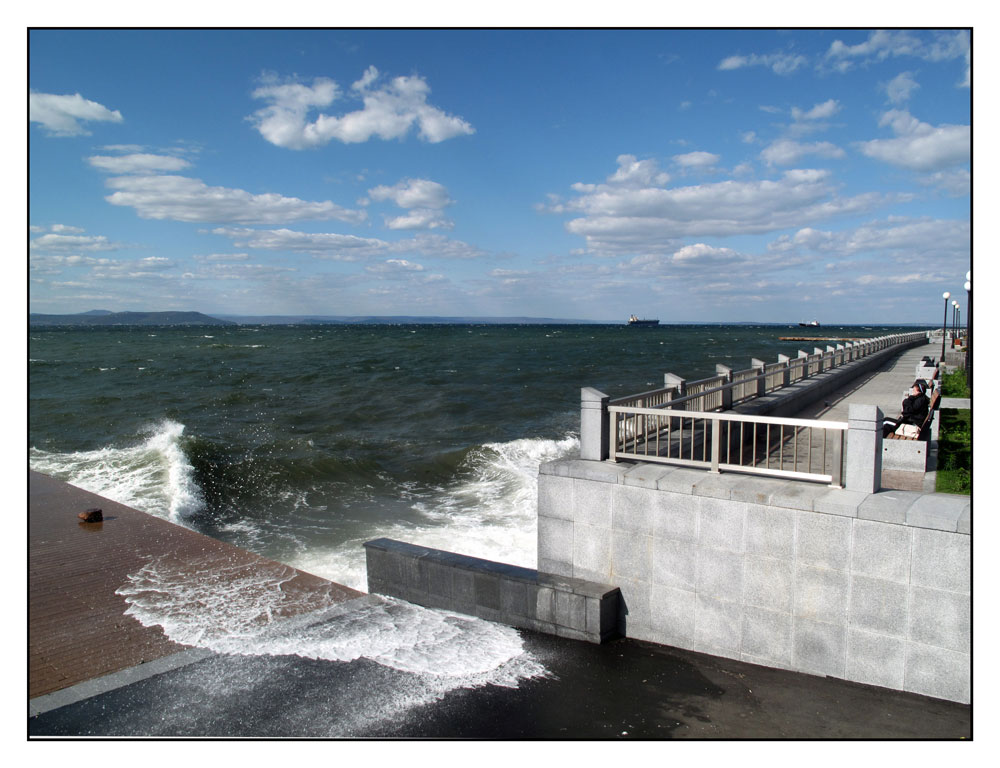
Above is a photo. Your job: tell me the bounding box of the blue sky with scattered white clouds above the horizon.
[28,29,972,325]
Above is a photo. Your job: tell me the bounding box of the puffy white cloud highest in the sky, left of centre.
[248,67,475,149]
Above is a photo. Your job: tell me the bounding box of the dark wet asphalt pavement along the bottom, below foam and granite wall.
[28,632,972,740]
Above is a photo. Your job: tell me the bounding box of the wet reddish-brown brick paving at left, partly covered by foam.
[28,472,362,698]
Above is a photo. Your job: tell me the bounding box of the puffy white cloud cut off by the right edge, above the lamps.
[858,109,972,171]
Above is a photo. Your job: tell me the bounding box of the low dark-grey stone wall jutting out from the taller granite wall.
[364,539,621,643]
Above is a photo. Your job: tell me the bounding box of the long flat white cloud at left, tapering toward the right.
[105,176,366,224]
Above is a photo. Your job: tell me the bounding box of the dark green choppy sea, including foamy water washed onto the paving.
[28,324,912,732]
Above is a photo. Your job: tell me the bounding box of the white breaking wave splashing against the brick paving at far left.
[29,420,204,523]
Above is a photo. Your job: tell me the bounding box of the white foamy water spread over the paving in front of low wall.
[117,558,548,711]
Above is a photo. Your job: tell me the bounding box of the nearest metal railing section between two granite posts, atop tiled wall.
[608,405,847,487]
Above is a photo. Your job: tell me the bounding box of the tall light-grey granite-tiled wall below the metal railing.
[538,459,971,703]
